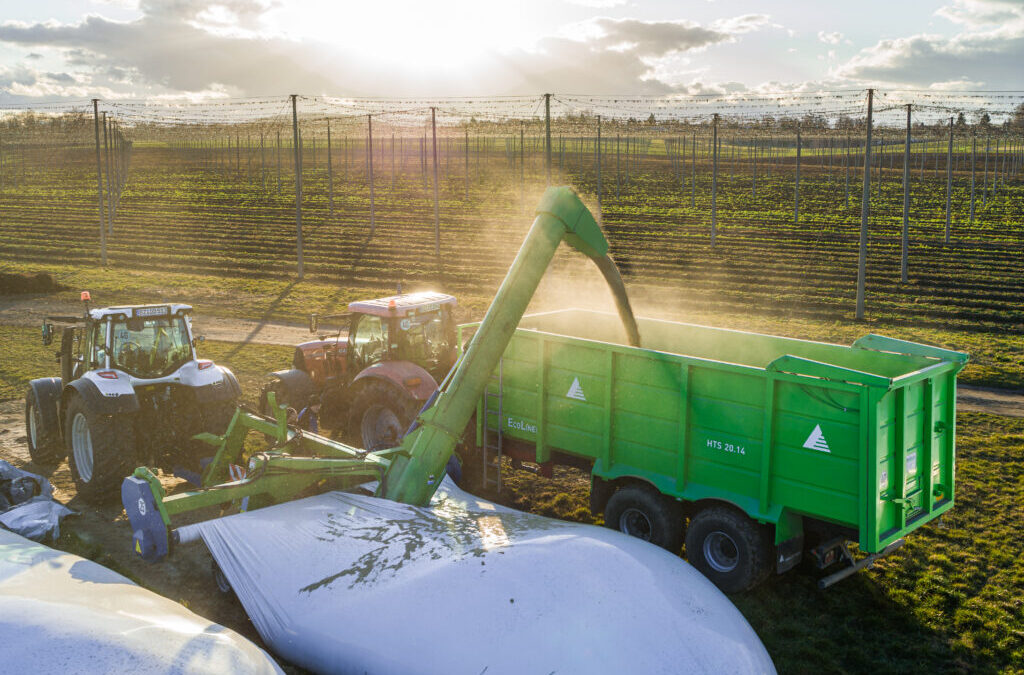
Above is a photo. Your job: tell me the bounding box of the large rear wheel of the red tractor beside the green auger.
[346,380,422,452]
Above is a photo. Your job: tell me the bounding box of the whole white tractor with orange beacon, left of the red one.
[25,292,241,502]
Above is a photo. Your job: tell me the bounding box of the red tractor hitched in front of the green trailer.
[260,292,457,451]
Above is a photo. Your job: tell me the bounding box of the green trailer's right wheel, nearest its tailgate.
[686,506,772,593]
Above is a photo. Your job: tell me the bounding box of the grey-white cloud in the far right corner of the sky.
[834,0,1024,88]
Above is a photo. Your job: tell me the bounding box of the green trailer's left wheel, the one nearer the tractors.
[604,483,684,553]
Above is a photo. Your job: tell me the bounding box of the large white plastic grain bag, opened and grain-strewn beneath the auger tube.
[198,480,774,675]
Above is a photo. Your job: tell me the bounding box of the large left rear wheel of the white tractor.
[65,396,135,504]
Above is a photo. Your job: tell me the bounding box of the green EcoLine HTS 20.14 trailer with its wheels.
[468,309,968,591]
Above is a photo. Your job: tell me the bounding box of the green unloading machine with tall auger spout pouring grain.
[122,187,640,560]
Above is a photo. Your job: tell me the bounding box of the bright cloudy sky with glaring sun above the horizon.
[0,0,1024,101]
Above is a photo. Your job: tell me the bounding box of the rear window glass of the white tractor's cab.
[111,317,193,378]
